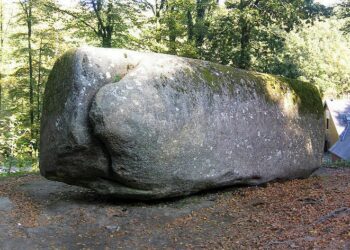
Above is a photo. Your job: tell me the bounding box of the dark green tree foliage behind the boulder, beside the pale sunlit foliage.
[206,0,329,69]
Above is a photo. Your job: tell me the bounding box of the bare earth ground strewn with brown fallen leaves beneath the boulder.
[0,168,350,249]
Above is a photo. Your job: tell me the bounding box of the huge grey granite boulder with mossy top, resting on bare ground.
[40,48,324,199]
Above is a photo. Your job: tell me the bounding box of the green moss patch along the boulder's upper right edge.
[177,61,323,118]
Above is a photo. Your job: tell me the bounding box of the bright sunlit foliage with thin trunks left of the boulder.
[0,0,76,174]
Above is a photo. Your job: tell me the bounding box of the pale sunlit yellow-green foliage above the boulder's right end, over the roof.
[274,19,350,97]
